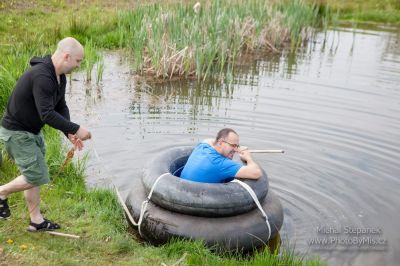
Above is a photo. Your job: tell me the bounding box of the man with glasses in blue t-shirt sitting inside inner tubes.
[181,128,262,183]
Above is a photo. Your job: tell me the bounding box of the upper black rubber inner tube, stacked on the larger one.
[142,147,268,217]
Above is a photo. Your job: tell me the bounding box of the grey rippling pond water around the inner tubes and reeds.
[67,25,400,265]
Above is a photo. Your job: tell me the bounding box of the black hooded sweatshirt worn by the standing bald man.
[1,56,79,136]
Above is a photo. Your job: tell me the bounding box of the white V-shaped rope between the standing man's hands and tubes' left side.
[90,138,169,236]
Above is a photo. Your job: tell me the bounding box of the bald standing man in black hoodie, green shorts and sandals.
[0,37,91,231]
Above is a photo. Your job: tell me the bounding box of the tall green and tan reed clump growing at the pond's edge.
[112,0,318,79]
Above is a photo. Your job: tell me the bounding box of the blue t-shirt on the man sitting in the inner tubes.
[181,143,242,183]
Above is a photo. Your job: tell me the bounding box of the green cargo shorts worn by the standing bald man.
[0,127,50,186]
